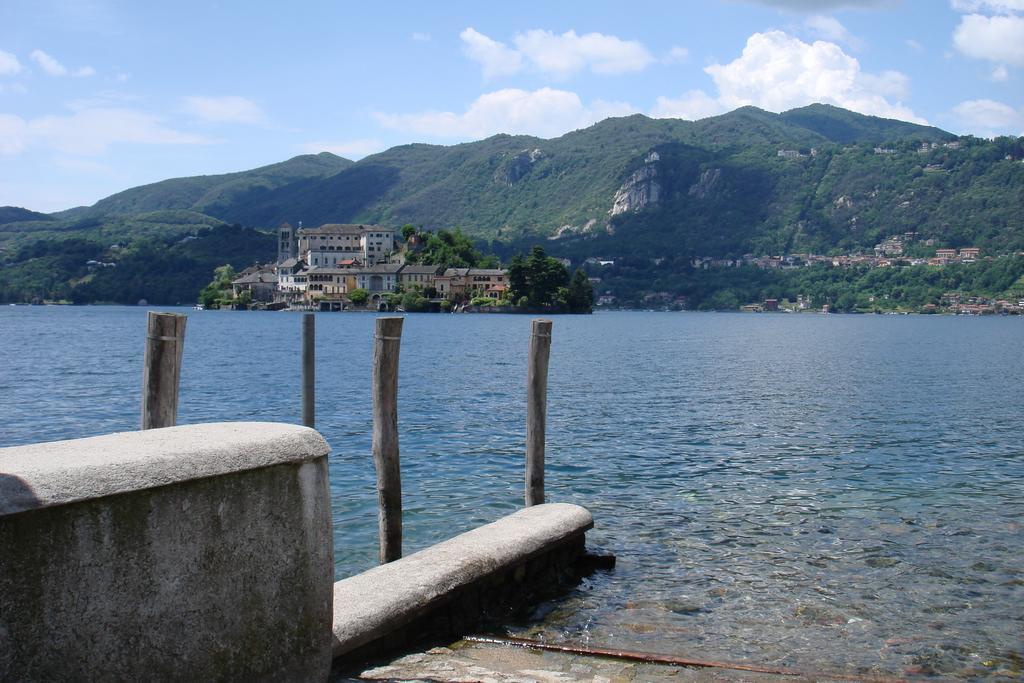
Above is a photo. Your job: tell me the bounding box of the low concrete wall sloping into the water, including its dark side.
[333,503,594,671]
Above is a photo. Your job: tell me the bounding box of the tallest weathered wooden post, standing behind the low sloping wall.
[373,317,402,564]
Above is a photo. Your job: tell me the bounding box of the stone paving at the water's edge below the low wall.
[335,641,810,683]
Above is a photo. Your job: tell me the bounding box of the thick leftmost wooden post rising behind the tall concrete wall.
[142,310,187,429]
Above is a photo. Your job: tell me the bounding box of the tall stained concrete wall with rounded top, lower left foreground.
[0,423,334,681]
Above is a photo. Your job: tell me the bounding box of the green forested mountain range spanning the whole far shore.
[0,104,1024,305]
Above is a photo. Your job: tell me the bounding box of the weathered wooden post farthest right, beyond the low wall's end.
[526,319,551,507]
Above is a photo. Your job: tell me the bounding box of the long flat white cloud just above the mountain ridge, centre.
[375,88,636,139]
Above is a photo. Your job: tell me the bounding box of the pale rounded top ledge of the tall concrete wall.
[0,422,330,515]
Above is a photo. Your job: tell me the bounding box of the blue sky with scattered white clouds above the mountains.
[0,0,1024,212]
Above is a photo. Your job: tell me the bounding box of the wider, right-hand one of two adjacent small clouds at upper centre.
[515,30,654,77]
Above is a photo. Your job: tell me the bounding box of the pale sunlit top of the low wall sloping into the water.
[333,503,594,658]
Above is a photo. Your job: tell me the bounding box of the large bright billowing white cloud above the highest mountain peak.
[689,31,927,123]
